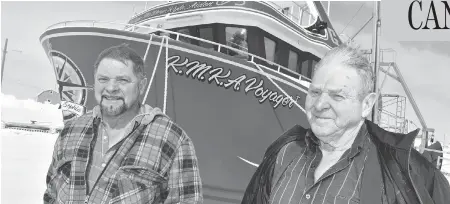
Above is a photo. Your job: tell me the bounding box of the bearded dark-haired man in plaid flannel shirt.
[44,45,203,204]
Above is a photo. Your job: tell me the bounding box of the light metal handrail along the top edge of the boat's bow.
[46,20,311,82]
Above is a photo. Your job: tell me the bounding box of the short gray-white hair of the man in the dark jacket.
[314,43,374,100]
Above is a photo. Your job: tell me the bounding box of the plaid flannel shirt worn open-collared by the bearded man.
[44,106,203,204]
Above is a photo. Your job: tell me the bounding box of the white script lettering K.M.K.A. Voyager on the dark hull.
[167,55,300,108]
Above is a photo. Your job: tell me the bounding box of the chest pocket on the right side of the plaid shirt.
[110,166,167,204]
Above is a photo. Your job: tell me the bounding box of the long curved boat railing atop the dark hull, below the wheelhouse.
[47,20,311,86]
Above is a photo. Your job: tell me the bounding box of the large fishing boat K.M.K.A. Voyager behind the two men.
[40,1,341,203]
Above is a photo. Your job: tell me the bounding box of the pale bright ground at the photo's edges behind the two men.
[0,129,450,204]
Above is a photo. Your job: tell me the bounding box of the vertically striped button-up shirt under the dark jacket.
[270,125,372,204]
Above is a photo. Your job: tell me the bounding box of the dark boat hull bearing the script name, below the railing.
[41,27,308,203]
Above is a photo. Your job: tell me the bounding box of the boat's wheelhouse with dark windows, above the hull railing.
[126,2,340,75]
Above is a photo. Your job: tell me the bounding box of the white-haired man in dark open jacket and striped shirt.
[242,45,450,204]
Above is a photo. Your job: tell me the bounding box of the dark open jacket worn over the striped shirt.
[242,120,450,204]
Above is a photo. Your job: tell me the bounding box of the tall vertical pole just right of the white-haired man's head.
[372,1,381,124]
